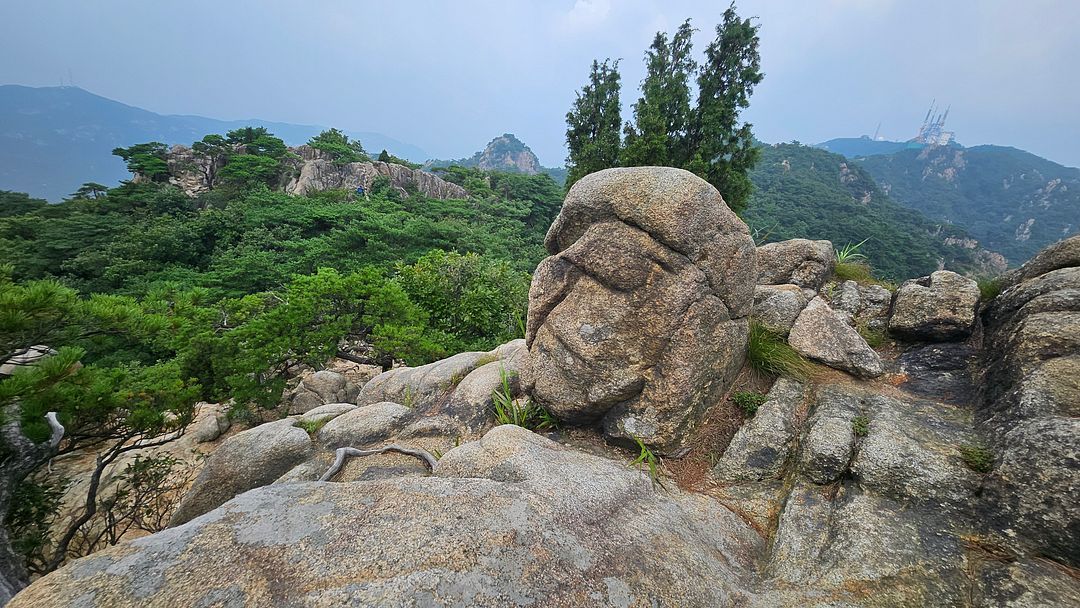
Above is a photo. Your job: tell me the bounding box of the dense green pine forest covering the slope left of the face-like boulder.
[0,127,563,582]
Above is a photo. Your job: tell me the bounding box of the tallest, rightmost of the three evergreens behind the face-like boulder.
[686,3,764,212]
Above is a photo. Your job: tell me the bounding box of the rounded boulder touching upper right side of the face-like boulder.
[757,239,836,292]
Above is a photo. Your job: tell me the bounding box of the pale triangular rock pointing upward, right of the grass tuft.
[787,297,885,378]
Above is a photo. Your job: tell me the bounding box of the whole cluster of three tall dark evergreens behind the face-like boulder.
[566,3,764,212]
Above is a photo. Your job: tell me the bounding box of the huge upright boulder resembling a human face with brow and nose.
[526,167,757,451]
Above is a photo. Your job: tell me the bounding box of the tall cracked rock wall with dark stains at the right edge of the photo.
[976,237,1080,567]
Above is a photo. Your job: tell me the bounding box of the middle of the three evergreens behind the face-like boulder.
[622,19,697,166]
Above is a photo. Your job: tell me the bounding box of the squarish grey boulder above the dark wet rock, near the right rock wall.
[889,270,978,342]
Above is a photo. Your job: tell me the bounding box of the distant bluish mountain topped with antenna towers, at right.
[854,146,1080,266]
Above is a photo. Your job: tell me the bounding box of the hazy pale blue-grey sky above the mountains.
[0,0,1080,166]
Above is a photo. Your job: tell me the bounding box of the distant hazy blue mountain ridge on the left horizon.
[0,84,428,201]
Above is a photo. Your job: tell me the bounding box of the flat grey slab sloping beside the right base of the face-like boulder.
[713,378,806,482]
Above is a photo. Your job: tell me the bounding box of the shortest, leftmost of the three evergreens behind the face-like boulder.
[566,59,622,188]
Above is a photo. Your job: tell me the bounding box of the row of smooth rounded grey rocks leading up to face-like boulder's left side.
[164,340,527,526]
